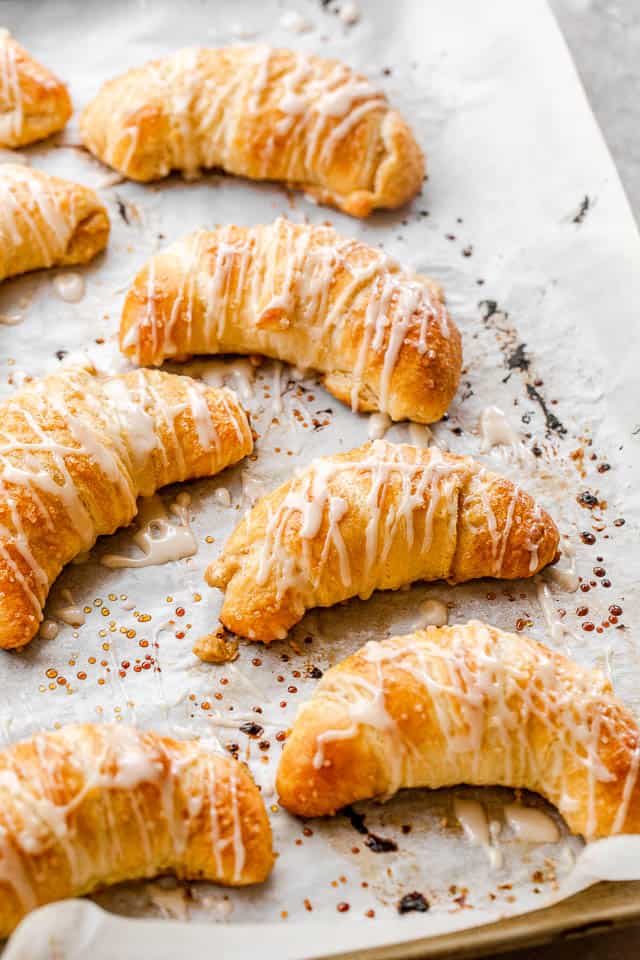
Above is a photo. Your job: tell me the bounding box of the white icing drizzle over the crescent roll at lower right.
[302,621,640,839]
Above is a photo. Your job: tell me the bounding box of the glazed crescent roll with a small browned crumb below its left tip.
[206,440,559,643]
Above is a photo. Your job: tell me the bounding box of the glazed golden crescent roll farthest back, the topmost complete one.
[80,44,424,217]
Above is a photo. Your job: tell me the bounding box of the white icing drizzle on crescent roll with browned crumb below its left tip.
[247,440,518,624]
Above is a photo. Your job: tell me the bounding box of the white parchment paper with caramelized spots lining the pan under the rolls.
[0,0,640,957]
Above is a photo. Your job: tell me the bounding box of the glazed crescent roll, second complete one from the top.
[120,219,462,423]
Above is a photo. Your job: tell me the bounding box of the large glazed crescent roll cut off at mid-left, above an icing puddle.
[0,369,253,648]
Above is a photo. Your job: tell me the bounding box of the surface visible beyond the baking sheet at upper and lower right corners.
[503,7,640,960]
